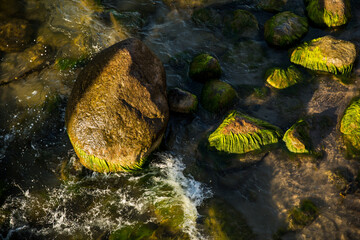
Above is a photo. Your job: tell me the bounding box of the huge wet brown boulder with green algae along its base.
[65,39,169,172]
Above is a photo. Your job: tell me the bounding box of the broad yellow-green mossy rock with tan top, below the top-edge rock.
[290,36,356,74]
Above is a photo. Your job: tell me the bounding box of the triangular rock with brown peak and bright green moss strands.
[208,111,282,154]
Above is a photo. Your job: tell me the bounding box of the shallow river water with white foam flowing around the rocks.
[0,0,360,240]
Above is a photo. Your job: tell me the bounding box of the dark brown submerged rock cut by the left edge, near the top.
[0,18,33,52]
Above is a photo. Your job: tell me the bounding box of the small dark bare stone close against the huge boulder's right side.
[168,88,198,113]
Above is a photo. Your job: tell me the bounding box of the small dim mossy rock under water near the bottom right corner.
[288,199,319,231]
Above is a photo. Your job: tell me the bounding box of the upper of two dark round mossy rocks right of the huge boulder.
[189,54,221,82]
